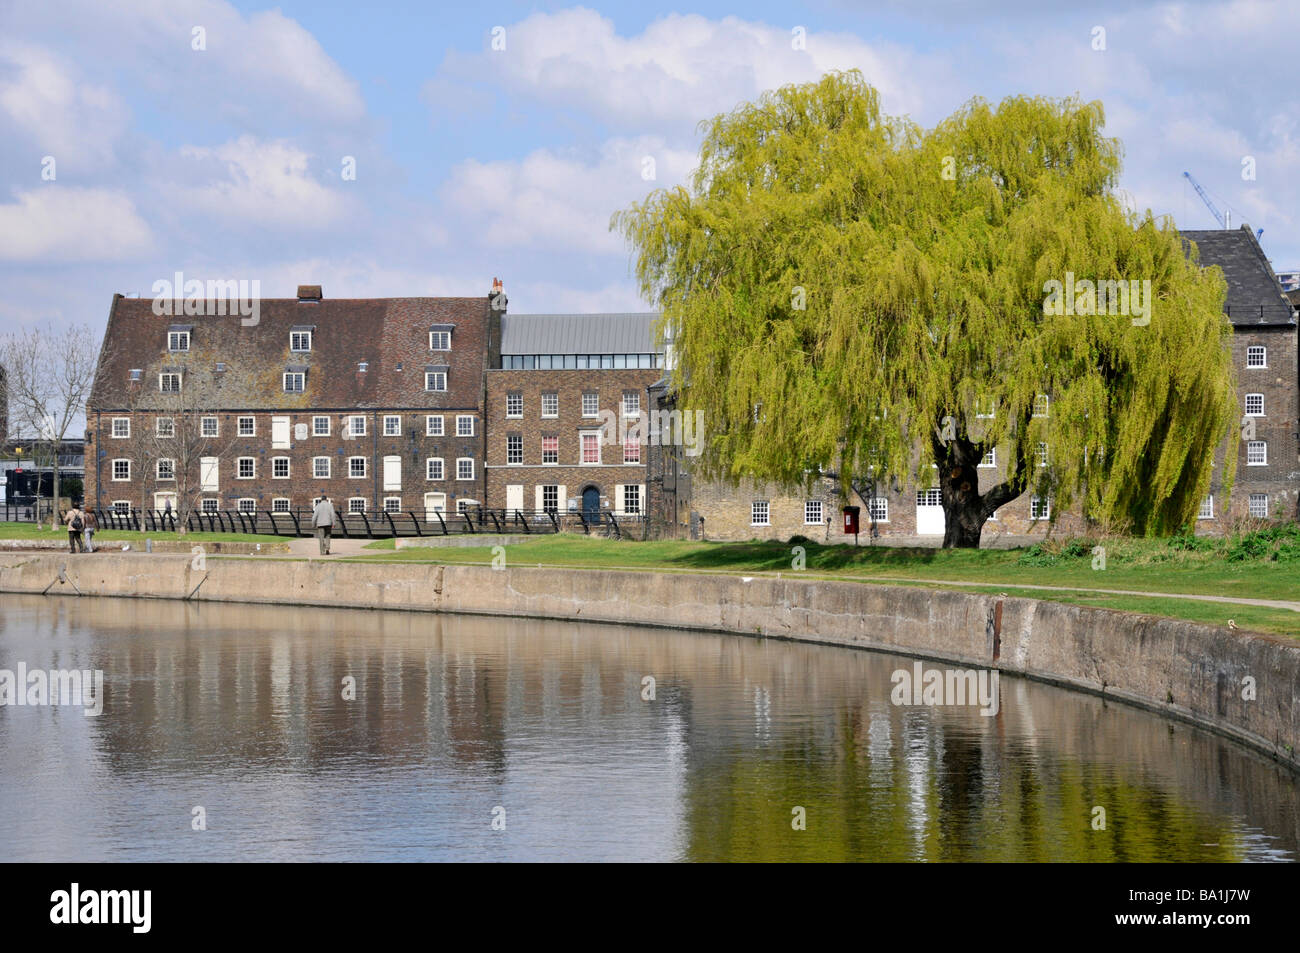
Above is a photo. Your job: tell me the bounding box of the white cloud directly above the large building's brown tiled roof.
[164,135,355,230]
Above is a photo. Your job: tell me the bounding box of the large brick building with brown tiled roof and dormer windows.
[86,282,506,512]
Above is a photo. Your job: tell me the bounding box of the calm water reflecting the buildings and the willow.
[0,595,1300,861]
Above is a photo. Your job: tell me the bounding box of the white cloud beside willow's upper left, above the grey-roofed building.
[443,137,697,254]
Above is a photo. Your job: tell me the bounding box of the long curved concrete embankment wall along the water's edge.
[0,554,1300,768]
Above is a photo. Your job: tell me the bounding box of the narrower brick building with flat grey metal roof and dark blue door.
[485,315,663,519]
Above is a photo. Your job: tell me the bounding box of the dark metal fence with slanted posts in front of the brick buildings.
[69,507,646,540]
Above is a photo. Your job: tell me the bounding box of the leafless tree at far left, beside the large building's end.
[0,324,99,529]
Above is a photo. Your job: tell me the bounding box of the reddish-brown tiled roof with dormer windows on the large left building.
[90,296,489,410]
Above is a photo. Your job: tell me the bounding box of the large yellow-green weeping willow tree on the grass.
[611,72,1236,546]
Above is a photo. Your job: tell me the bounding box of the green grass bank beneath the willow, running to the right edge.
[350,529,1300,636]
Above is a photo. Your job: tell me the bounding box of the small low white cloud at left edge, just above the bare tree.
[0,185,152,263]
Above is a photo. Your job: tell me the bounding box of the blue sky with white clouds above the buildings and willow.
[0,0,1300,334]
